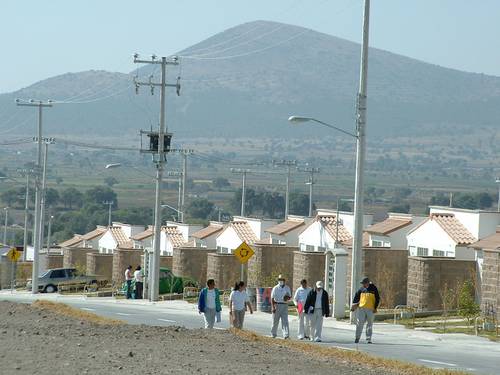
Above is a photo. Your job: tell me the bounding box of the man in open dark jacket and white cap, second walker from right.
[304,281,330,342]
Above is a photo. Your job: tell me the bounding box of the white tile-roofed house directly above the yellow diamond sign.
[216,216,277,254]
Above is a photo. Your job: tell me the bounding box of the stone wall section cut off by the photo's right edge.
[481,249,500,319]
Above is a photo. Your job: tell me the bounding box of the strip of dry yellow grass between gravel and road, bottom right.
[231,329,467,375]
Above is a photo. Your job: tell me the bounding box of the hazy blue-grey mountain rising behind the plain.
[0,21,500,138]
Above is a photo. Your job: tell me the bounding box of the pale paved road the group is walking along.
[0,292,500,374]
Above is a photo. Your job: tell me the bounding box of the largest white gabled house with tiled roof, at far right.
[407,206,500,260]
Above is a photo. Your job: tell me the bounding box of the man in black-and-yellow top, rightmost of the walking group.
[351,277,380,344]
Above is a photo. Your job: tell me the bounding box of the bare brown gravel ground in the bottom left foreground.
[0,302,394,375]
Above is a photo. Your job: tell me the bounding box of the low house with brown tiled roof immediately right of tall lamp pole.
[365,213,425,250]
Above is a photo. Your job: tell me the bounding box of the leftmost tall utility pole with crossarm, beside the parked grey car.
[16,99,52,294]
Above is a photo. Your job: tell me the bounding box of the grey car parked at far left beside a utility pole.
[26,268,102,293]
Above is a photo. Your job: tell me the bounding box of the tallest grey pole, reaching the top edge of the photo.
[350,0,370,323]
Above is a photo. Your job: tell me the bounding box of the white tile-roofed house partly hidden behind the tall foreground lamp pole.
[299,210,373,251]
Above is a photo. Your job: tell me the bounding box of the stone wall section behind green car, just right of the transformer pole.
[172,247,215,285]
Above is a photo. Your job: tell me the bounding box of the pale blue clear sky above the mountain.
[0,0,500,93]
